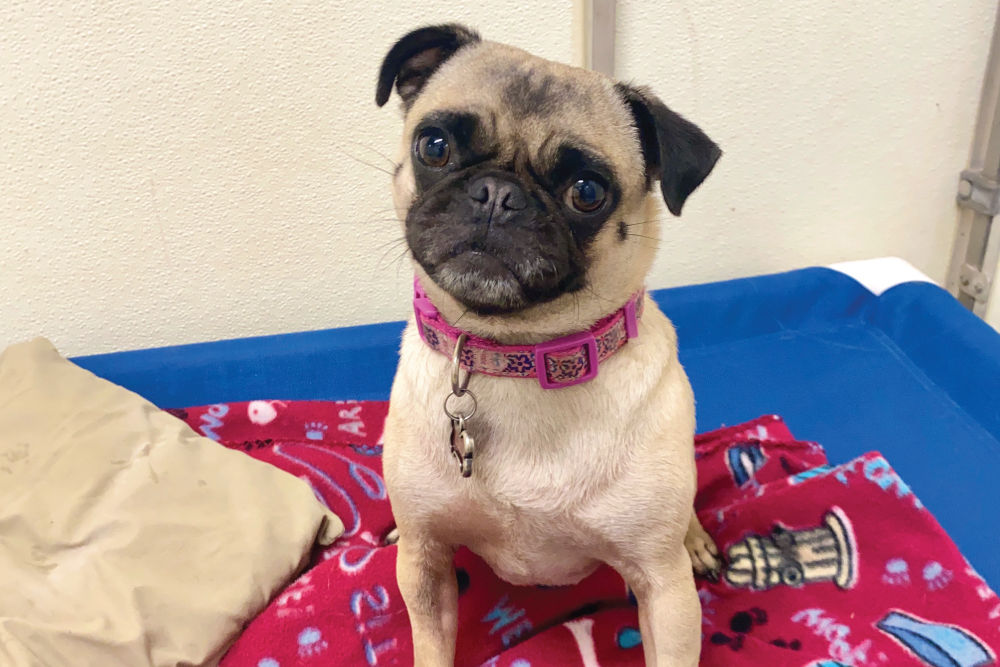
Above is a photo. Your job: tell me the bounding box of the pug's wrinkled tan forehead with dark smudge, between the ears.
[405,42,644,194]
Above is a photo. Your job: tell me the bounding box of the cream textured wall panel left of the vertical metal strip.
[0,0,574,354]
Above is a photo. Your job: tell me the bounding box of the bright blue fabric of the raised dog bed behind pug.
[74,268,1000,588]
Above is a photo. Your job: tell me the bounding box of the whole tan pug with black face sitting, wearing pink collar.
[376,25,721,667]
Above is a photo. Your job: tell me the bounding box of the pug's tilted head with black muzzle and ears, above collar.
[376,25,721,340]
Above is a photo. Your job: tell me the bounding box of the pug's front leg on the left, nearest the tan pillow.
[396,531,458,667]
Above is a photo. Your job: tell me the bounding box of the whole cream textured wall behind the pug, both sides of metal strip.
[0,0,994,354]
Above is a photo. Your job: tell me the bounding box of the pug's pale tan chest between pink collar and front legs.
[385,322,693,585]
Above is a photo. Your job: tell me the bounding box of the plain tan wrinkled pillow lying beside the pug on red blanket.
[0,339,343,667]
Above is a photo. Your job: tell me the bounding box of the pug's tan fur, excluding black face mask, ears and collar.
[383,36,715,667]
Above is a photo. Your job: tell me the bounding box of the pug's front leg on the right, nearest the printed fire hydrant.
[623,544,701,667]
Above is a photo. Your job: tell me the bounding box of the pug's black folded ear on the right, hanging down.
[615,83,722,215]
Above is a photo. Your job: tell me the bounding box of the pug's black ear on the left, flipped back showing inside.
[375,23,479,109]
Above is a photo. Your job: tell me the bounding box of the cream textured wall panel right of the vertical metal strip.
[617,0,996,286]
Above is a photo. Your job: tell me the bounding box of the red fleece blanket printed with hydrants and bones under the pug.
[174,401,1000,667]
